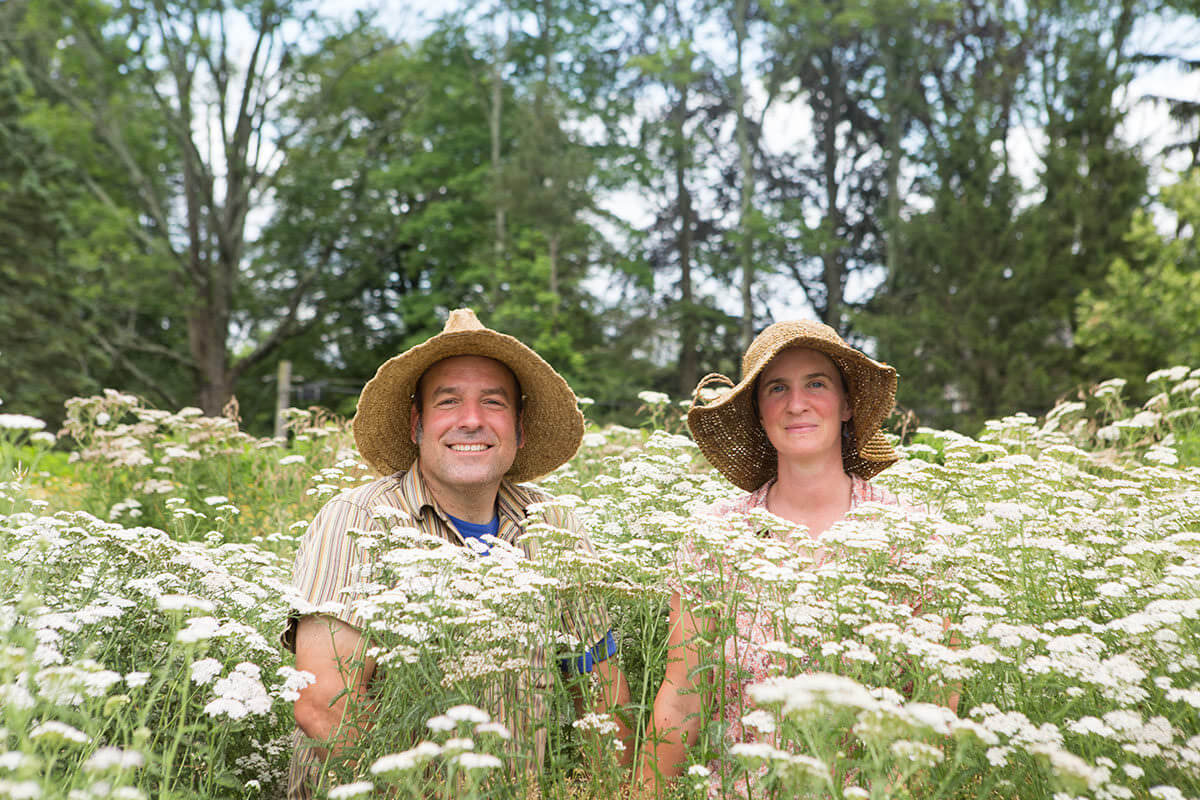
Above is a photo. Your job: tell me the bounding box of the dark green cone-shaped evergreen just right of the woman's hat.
[854,115,1056,429]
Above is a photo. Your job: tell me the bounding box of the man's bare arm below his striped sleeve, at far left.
[293,615,374,753]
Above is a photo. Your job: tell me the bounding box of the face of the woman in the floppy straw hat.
[756,348,852,461]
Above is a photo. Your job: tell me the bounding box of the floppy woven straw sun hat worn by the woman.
[688,320,900,492]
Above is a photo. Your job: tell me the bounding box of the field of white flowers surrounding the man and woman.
[0,368,1200,800]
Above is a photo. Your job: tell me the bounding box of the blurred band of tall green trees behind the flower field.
[0,0,1200,432]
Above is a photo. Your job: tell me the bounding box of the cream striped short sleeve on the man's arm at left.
[280,498,380,652]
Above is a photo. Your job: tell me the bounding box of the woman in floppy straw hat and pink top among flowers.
[640,321,900,793]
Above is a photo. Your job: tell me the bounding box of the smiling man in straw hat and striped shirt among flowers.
[282,308,632,800]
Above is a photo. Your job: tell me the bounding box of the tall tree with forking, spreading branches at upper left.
[5,0,352,414]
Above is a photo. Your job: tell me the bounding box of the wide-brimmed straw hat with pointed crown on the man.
[354,308,583,481]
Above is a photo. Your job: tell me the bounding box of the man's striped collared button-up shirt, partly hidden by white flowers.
[280,465,610,800]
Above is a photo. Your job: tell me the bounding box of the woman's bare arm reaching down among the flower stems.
[634,591,708,798]
